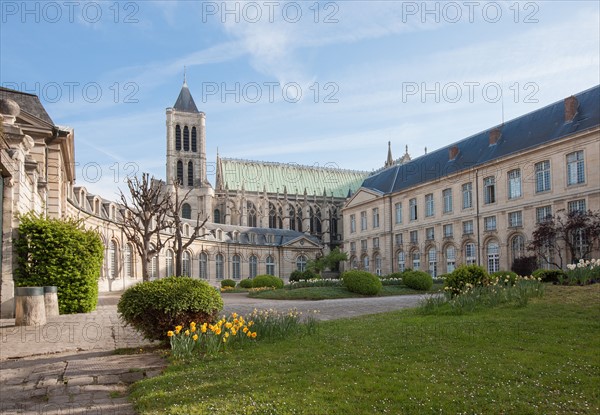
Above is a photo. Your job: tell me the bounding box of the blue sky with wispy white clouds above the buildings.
[0,0,600,199]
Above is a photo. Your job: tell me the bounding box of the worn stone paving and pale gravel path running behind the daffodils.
[0,292,432,415]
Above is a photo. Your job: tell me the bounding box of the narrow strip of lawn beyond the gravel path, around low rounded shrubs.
[248,284,443,300]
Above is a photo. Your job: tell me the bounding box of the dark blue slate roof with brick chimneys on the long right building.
[362,85,600,194]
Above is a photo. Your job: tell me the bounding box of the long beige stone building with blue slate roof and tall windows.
[342,87,600,276]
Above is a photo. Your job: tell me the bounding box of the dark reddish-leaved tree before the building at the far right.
[528,210,600,269]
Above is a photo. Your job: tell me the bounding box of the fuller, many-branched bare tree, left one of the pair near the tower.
[119,173,173,281]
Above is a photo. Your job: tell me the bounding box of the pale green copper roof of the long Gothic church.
[217,158,369,198]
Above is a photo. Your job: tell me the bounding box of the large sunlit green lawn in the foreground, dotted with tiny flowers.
[131,284,600,415]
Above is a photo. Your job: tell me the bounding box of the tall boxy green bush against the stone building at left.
[15,214,104,314]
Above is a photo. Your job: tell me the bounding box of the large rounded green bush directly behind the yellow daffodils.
[117,277,223,341]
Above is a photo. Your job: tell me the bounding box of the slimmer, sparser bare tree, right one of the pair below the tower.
[167,181,208,276]
